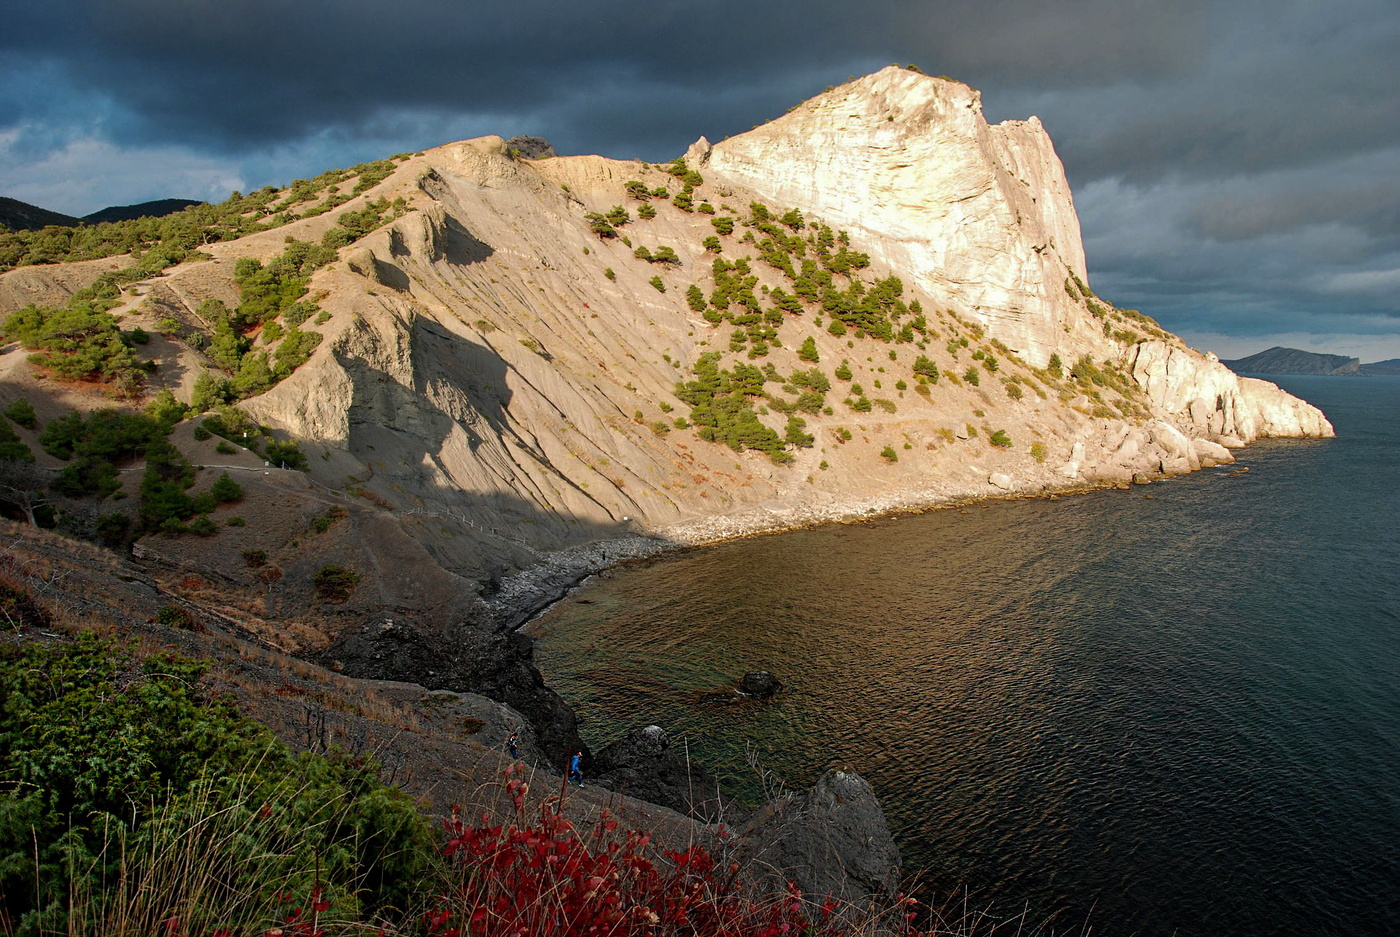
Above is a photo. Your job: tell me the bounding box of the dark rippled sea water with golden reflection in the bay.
[533,378,1400,937]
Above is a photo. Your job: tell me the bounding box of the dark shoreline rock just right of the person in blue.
[589,726,720,819]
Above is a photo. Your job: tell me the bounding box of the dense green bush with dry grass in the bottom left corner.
[0,633,431,933]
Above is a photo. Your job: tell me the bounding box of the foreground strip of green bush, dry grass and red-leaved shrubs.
[0,627,1030,937]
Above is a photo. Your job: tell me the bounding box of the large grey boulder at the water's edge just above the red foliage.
[738,770,899,903]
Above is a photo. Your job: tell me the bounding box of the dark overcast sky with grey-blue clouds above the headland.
[0,0,1400,361]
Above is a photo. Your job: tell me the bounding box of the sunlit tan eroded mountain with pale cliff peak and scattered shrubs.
[7,67,1331,602]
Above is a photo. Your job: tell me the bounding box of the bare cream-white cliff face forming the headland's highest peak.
[706,66,1107,366]
